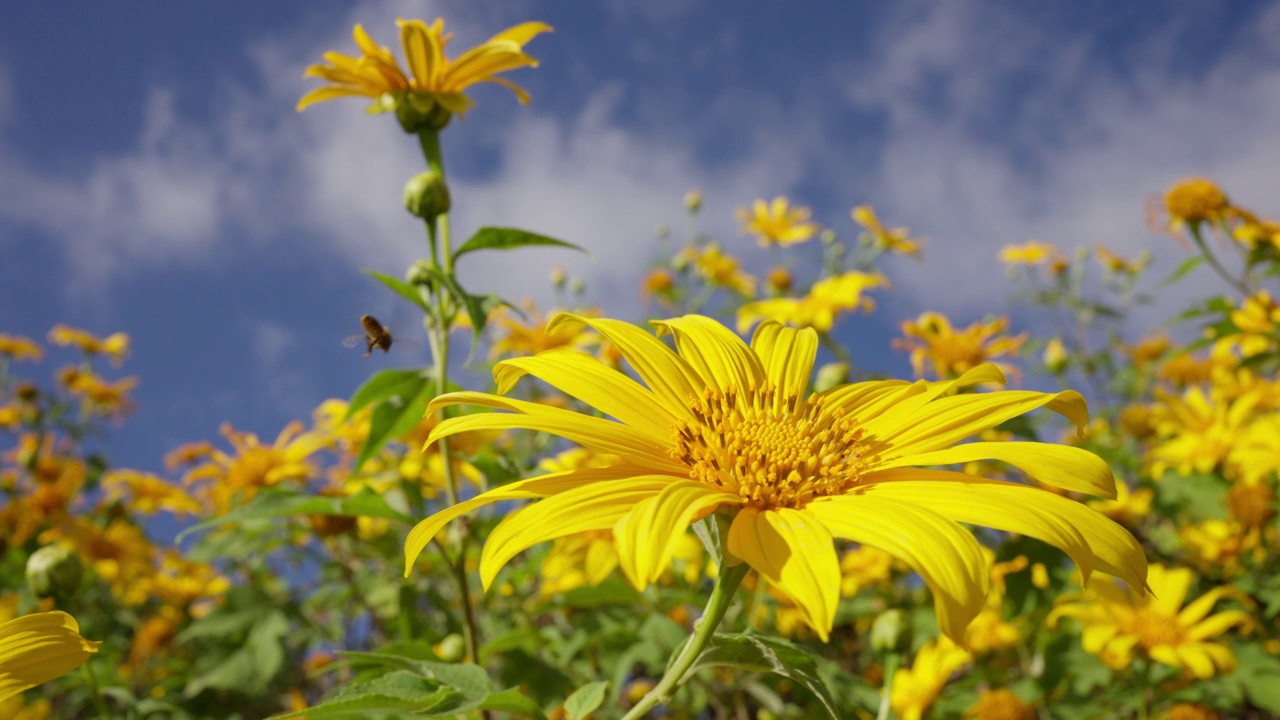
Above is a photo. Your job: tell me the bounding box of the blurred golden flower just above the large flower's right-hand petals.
[893,311,1027,379]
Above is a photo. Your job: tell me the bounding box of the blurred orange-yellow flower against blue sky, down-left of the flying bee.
[183,421,330,515]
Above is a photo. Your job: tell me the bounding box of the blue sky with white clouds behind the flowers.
[0,0,1280,479]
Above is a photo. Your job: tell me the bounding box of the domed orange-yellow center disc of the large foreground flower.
[675,387,867,507]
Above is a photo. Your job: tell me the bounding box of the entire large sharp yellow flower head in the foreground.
[406,314,1146,638]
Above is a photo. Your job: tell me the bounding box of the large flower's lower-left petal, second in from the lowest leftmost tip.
[480,475,675,589]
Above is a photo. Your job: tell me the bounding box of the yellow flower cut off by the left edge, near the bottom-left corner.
[0,611,101,700]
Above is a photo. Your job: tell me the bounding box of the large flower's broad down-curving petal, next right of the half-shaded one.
[806,493,988,644]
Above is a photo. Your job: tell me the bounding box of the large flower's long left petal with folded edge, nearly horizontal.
[426,392,689,475]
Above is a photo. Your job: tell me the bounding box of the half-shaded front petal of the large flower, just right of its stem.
[728,507,841,642]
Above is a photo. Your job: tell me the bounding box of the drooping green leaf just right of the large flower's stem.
[689,633,840,720]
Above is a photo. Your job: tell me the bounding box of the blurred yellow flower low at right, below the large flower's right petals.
[1048,565,1253,680]
